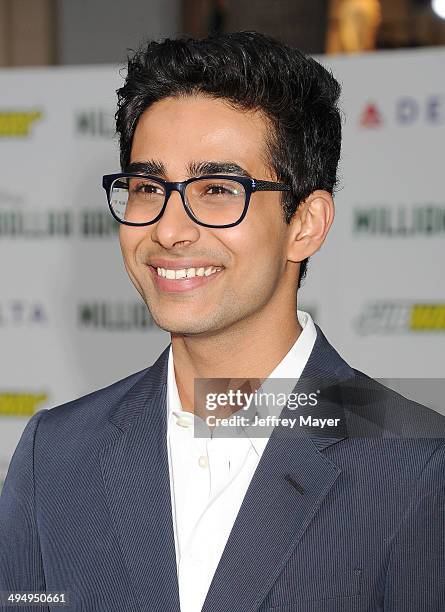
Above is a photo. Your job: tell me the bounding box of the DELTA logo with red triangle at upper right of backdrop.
[358,94,445,129]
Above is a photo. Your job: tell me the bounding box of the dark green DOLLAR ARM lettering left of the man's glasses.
[0,207,119,238]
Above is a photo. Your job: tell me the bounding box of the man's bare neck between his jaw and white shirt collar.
[172,302,302,412]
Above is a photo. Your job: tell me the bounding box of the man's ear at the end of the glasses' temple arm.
[288,189,335,262]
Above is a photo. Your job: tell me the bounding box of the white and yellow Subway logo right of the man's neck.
[354,300,445,335]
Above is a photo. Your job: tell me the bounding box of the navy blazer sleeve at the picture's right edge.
[383,442,445,612]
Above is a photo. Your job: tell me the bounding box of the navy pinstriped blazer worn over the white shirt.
[0,326,445,612]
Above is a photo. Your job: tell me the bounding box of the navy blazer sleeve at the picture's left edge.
[0,410,49,612]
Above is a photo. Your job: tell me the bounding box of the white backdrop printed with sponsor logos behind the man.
[0,49,445,488]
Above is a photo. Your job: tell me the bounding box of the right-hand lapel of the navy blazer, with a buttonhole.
[202,326,354,612]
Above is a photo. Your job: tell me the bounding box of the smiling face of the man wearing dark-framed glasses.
[120,96,298,334]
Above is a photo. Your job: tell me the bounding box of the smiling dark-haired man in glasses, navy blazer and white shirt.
[0,32,445,612]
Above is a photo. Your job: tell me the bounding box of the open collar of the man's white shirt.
[167,310,317,456]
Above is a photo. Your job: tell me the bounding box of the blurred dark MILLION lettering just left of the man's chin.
[77,301,155,331]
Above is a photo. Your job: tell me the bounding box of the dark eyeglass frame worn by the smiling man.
[102,172,292,229]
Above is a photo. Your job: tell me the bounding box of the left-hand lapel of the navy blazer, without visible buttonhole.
[100,348,180,612]
